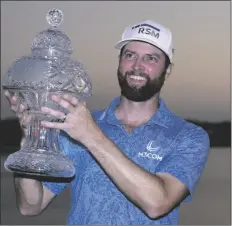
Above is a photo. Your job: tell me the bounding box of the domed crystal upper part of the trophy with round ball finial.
[3,9,92,97]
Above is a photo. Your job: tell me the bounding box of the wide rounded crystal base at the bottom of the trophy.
[4,149,75,178]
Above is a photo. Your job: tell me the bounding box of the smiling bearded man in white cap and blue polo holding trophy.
[5,20,210,225]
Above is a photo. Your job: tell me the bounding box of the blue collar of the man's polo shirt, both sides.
[99,97,171,128]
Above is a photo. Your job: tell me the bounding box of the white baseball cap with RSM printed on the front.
[115,20,173,63]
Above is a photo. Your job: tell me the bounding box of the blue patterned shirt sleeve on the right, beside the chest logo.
[156,124,210,202]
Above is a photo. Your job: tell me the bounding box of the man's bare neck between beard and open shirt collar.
[115,95,159,126]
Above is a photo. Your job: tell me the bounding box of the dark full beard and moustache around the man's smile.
[117,69,165,102]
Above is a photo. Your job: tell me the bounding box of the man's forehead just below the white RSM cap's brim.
[124,41,164,55]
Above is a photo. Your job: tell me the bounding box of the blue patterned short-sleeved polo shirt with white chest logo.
[44,97,210,225]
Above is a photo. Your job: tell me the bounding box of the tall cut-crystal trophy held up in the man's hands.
[3,9,92,178]
